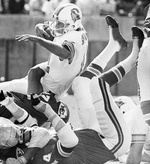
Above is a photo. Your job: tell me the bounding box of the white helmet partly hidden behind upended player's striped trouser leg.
[114,96,136,114]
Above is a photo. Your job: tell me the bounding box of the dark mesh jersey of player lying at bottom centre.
[33,129,115,164]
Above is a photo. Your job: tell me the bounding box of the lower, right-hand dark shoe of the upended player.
[132,26,144,49]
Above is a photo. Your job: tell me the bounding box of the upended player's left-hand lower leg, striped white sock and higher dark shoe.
[81,16,127,78]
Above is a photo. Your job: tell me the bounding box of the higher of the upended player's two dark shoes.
[106,15,127,50]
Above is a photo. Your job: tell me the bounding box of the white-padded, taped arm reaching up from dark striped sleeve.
[32,95,78,156]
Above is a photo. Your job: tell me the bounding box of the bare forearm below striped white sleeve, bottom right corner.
[126,143,144,164]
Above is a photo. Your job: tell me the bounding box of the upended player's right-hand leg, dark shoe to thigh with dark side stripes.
[91,27,144,157]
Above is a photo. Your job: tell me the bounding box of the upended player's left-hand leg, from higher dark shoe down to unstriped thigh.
[72,16,127,129]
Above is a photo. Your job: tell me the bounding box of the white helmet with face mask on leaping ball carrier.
[50,3,82,37]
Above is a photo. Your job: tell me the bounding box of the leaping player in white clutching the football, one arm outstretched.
[0,3,88,100]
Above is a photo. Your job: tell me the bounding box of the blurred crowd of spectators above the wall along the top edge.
[0,0,149,17]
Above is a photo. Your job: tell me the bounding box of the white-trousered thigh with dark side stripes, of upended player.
[91,77,131,158]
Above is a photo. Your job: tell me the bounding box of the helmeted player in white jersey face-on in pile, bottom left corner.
[0,117,55,164]
